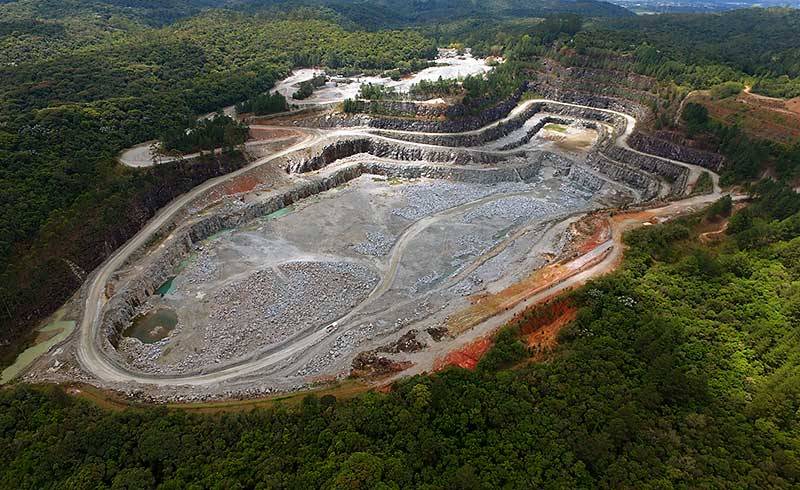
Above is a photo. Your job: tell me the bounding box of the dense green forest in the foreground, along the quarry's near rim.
[0,186,800,489]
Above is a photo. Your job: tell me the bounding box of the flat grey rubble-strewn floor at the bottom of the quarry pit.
[119,170,611,382]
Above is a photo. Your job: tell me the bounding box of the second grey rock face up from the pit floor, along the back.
[285,138,522,173]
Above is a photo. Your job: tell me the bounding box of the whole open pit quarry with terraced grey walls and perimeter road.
[20,72,720,401]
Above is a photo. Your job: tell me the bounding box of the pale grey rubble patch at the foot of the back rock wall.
[392,180,531,221]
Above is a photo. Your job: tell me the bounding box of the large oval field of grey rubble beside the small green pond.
[125,262,378,373]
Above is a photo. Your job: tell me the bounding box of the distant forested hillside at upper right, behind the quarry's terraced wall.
[591,8,800,96]
